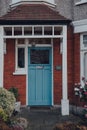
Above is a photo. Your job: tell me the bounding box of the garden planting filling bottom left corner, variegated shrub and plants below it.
[0,88,24,130]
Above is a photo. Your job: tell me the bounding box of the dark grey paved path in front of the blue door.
[19,108,80,130]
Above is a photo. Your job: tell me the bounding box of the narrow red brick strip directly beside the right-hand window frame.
[74,34,81,106]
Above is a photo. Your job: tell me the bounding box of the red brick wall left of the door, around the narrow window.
[4,40,26,104]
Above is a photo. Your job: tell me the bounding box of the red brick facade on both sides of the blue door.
[4,26,75,104]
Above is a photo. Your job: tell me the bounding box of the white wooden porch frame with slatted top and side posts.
[0,25,69,115]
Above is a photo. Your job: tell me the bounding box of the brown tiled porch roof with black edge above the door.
[0,4,70,25]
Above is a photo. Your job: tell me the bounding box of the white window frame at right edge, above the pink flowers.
[80,33,87,84]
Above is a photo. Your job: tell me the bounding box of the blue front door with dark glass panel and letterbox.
[28,47,52,106]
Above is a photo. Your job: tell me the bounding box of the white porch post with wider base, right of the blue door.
[61,26,69,115]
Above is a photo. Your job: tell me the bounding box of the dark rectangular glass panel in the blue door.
[30,49,49,64]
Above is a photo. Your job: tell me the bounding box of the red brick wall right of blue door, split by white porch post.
[53,26,74,104]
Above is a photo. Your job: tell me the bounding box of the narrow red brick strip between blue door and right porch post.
[53,39,62,104]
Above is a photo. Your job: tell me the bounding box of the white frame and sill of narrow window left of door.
[13,39,27,75]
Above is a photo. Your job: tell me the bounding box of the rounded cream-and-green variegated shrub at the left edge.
[0,88,16,117]
